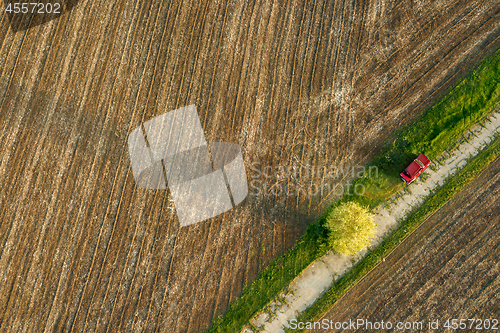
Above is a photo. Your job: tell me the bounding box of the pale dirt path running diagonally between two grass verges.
[242,112,500,333]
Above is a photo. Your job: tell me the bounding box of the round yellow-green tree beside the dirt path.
[326,202,375,255]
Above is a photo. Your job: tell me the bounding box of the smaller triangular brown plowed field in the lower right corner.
[312,159,500,332]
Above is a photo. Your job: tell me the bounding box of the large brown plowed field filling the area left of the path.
[0,0,500,332]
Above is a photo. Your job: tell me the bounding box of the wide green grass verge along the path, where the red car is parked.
[205,46,500,332]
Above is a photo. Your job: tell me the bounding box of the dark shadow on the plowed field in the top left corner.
[2,0,79,32]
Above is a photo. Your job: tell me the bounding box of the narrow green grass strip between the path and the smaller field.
[287,130,500,332]
